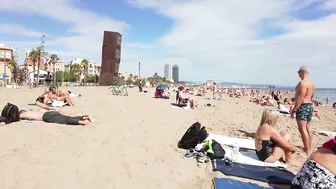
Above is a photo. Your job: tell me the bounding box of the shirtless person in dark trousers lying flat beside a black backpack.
[20,110,91,125]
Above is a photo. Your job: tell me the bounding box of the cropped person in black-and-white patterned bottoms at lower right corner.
[291,137,336,189]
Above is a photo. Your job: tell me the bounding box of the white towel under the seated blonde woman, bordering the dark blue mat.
[223,147,287,168]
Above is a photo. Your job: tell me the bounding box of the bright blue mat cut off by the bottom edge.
[213,177,277,189]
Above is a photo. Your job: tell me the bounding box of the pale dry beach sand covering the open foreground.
[0,87,336,189]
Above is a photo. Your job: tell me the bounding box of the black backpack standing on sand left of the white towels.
[177,122,209,150]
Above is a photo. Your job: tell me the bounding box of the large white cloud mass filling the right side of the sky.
[128,0,336,87]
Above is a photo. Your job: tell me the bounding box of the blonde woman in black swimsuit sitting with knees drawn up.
[255,109,296,164]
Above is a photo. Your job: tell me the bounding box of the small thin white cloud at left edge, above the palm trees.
[0,23,43,37]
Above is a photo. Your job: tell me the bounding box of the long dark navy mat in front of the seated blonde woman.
[212,160,295,184]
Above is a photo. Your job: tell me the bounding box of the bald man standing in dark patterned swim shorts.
[291,66,315,155]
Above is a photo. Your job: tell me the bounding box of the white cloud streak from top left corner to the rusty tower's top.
[0,0,129,54]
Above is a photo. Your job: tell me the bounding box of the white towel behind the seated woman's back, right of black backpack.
[206,133,255,150]
